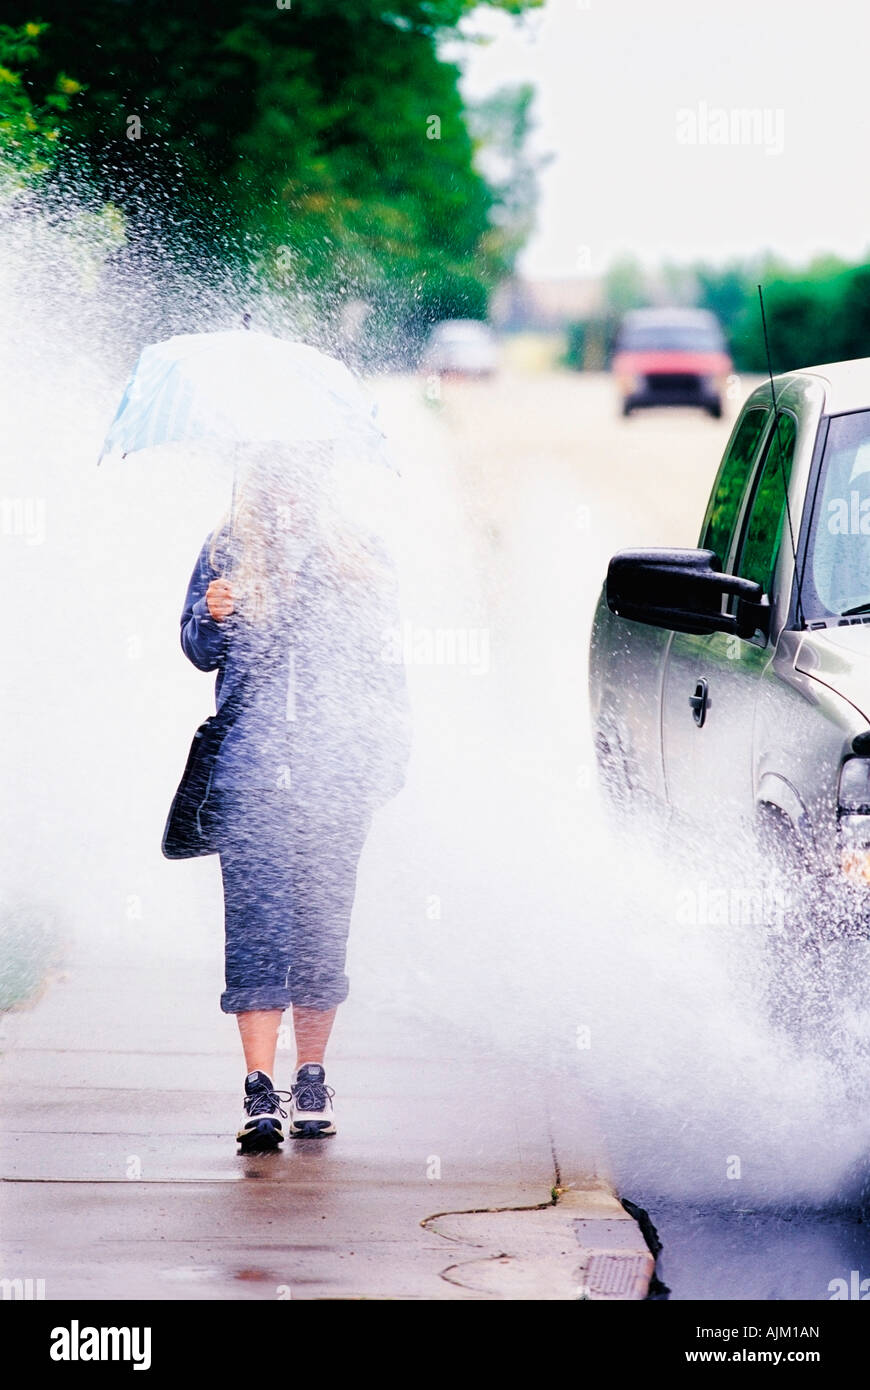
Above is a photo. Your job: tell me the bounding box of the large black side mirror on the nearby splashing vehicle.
[605,550,770,637]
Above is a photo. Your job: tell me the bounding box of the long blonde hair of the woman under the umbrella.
[208,442,382,624]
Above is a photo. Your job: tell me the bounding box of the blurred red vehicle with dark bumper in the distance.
[612,309,731,418]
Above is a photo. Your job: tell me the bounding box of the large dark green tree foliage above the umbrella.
[3,0,539,353]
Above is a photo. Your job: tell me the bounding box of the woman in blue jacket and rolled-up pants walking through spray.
[181,445,410,1151]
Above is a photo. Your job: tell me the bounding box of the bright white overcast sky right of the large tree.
[450,0,870,277]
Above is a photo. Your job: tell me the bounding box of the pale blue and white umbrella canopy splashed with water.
[100,329,389,461]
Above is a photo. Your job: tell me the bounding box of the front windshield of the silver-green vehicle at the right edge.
[806,410,870,617]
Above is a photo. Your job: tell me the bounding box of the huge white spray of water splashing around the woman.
[0,209,867,1201]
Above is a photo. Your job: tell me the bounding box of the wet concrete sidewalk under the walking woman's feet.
[0,941,652,1300]
